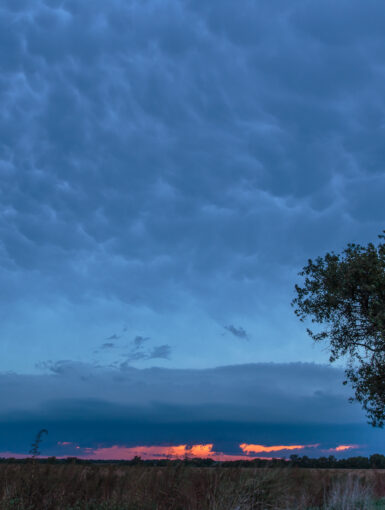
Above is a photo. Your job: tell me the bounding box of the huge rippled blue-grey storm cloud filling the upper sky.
[0,0,385,312]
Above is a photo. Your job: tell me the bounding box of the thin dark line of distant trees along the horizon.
[0,453,385,469]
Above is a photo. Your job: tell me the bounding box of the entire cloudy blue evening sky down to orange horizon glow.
[0,0,385,458]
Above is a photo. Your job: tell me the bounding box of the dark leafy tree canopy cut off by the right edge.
[292,231,385,427]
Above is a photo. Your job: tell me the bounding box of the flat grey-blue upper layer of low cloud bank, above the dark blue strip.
[0,361,365,423]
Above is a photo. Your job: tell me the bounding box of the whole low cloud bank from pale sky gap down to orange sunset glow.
[0,361,383,455]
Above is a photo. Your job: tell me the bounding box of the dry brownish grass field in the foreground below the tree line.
[0,463,385,510]
